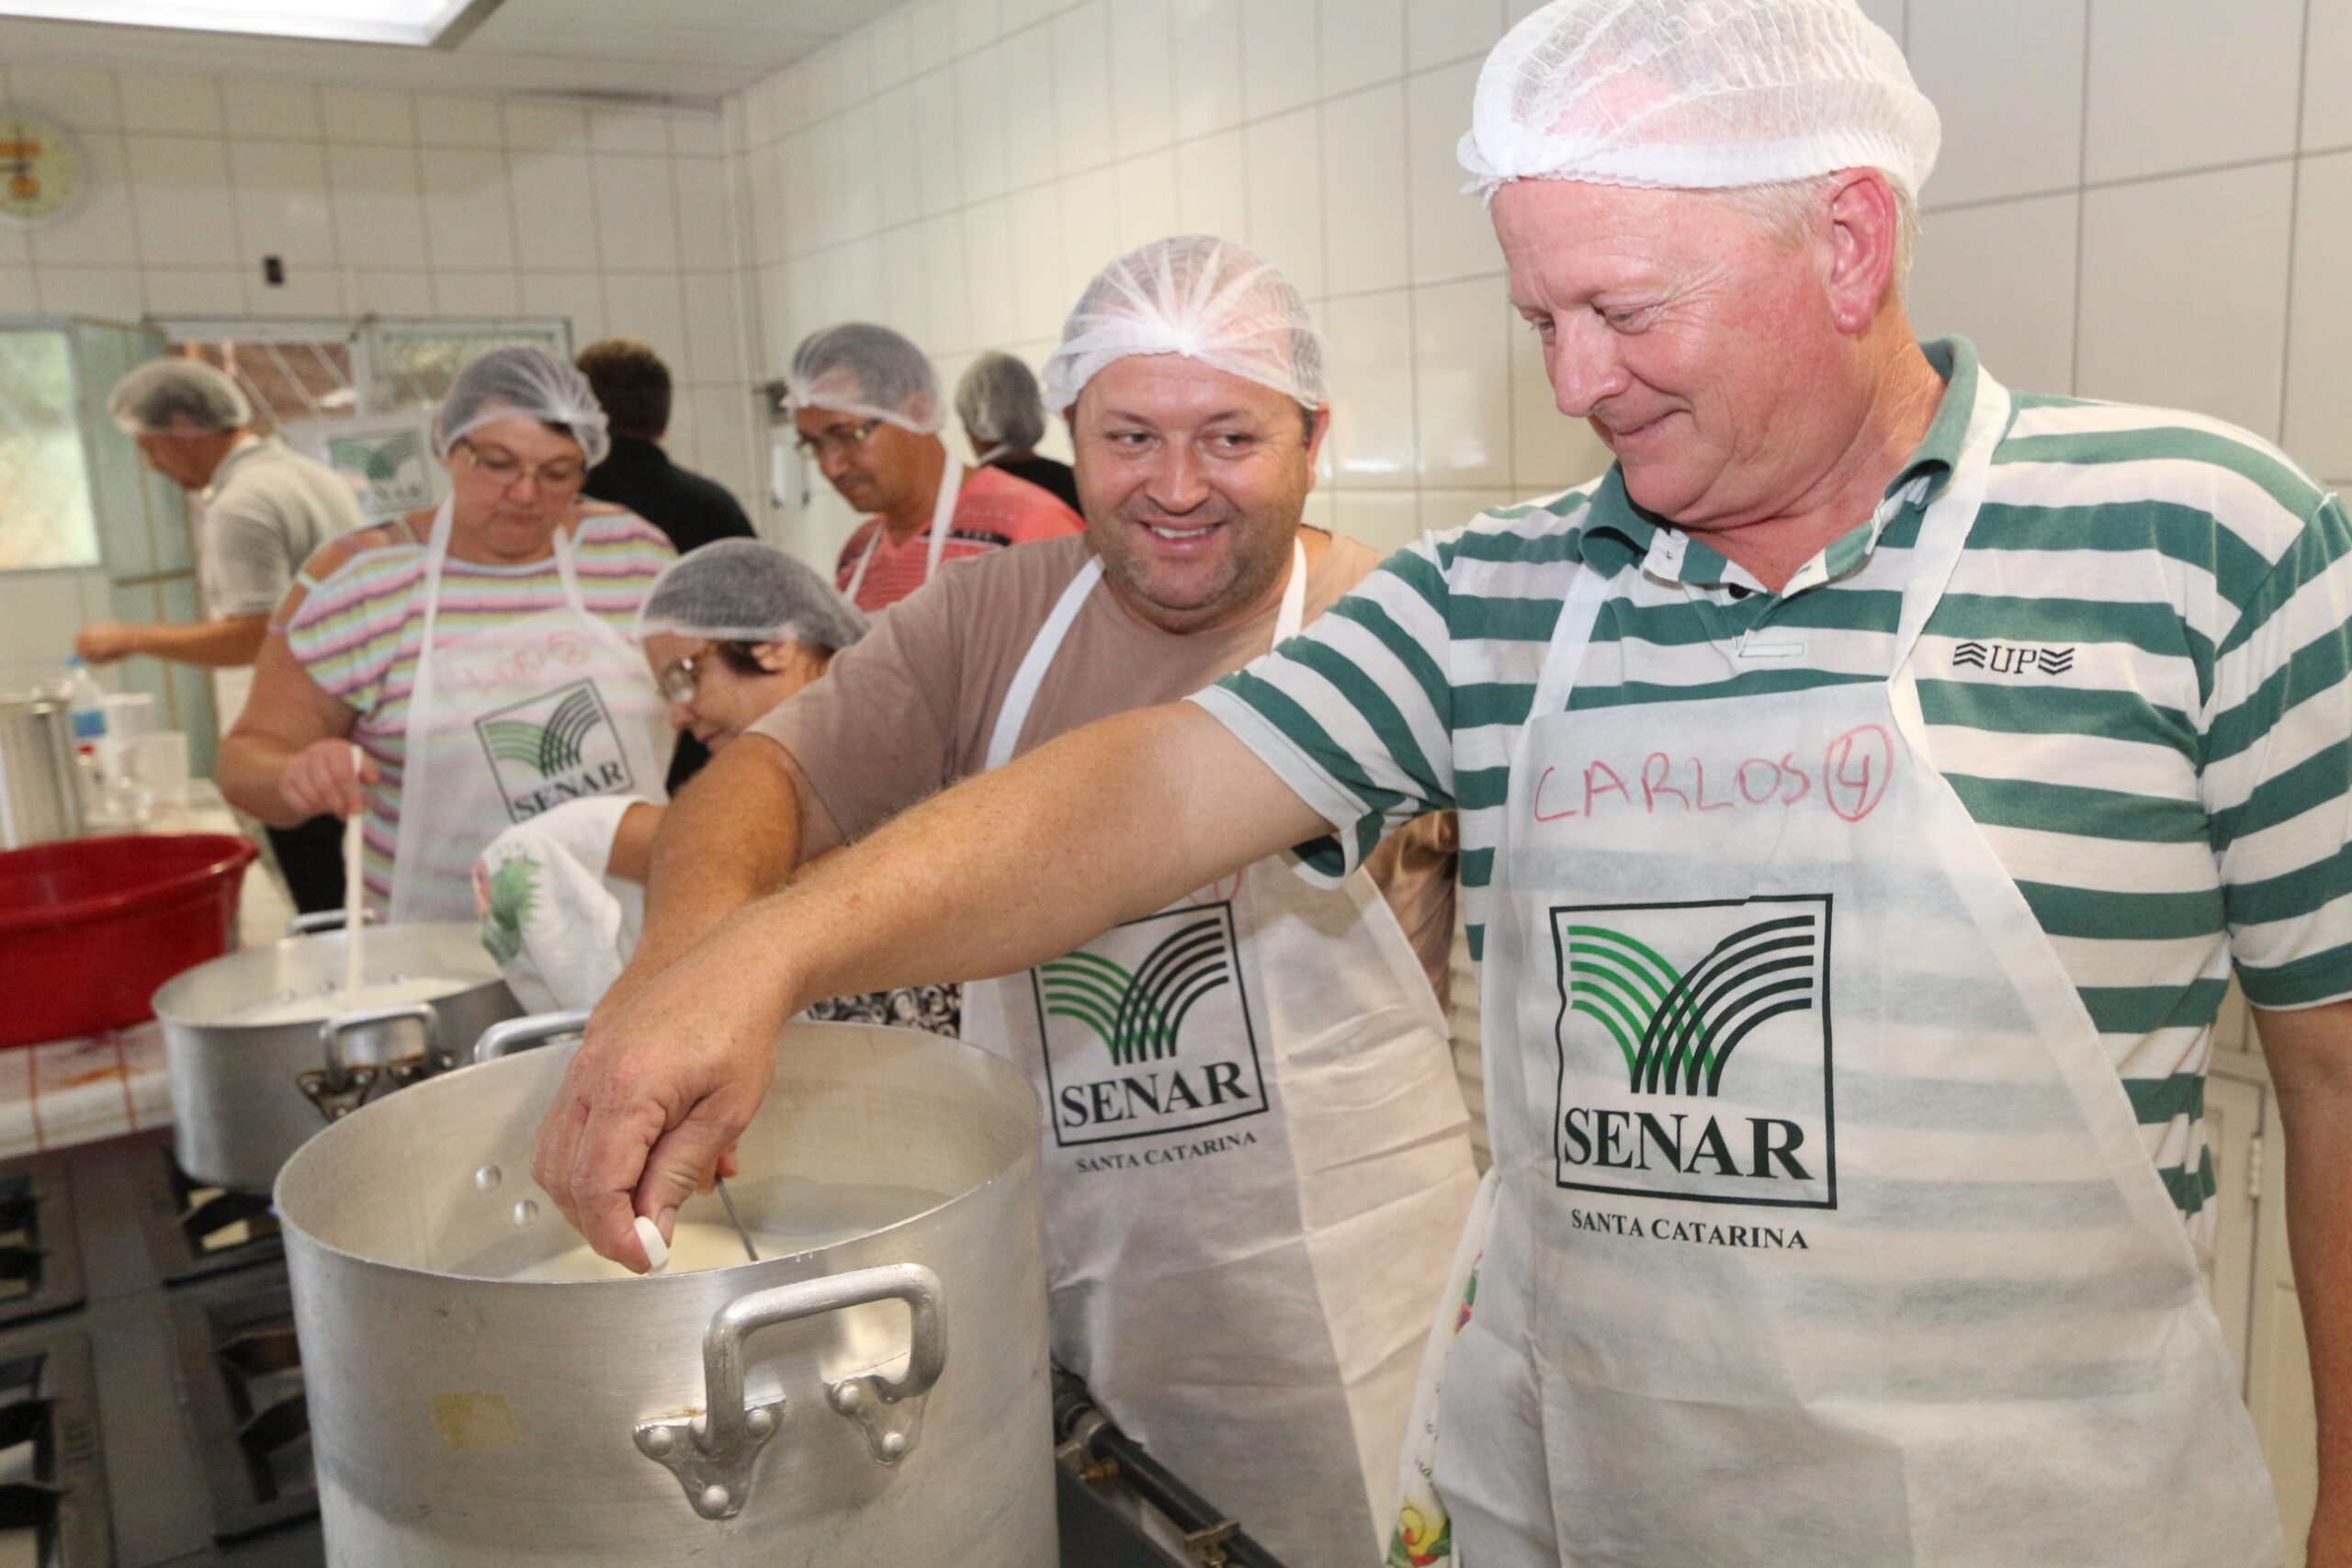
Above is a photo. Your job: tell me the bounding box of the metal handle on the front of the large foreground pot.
[638,1262,948,1518]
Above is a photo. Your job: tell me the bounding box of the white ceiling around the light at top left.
[0,0,899,104]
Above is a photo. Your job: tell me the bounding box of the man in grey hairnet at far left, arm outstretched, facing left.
[73,357,362,915]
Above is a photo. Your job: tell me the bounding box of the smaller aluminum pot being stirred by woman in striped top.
[155,917,522,1194]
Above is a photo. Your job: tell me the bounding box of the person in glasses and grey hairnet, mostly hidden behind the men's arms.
[475,538,957,1037]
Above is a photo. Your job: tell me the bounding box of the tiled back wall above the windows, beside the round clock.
[0,63,762,499]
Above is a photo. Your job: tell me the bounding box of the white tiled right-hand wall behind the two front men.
[727,0,2352,576]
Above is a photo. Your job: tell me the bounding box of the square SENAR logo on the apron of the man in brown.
[1030,903,1265,1147]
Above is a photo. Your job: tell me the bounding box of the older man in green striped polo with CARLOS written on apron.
[524,0,2352,1568]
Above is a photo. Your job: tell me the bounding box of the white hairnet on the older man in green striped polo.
[1461,0,1943,197]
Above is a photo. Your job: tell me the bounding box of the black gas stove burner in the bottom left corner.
[0,1328,115,1568]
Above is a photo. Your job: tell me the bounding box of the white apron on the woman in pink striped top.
[390,501,675,924]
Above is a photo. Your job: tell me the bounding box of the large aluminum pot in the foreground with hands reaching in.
[277,1021,1056,1568]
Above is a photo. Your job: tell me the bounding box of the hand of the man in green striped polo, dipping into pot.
[532,929,790,1274]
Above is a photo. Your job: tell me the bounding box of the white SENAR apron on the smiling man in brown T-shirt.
[965,550,1477,1568]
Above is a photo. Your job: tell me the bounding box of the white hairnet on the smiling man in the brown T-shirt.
[1045,235,1324,413]
